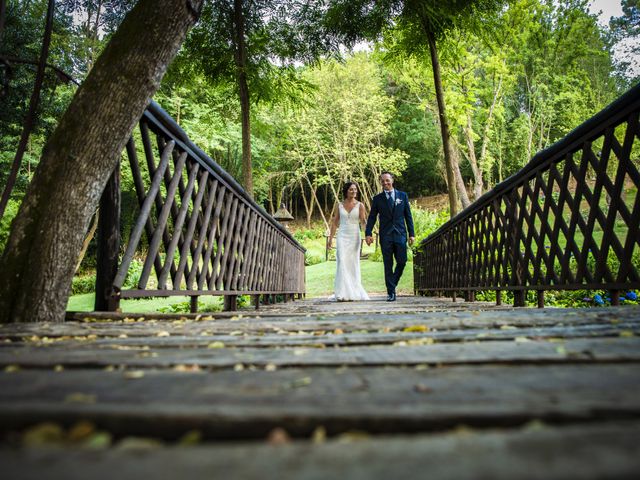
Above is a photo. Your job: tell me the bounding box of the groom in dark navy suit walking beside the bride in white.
[365,172,415,302]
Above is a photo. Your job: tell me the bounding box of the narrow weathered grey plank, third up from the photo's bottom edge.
[0,338,640,368]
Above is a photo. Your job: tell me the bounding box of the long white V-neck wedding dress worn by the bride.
[332,202,369,301]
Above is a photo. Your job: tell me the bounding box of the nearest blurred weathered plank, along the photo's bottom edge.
[0,422,640,480]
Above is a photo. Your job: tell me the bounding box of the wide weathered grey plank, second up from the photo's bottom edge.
[0,365,640,439]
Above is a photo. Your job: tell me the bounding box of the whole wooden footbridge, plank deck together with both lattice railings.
[0,87,640,479]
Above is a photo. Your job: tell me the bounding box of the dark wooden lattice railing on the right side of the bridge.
[414,86,640,306]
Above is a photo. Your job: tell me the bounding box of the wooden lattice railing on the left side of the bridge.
[96,102,305,311]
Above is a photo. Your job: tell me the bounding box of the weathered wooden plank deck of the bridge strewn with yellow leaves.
[0,297,640,479]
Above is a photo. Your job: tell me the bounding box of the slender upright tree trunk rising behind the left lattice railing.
[233,0,253,197]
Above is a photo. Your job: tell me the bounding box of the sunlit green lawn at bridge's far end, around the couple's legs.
[306,260,413,297]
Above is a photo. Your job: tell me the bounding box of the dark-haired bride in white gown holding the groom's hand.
[327,182,369,302]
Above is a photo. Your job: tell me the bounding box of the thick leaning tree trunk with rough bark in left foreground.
[0,0,203,323]
